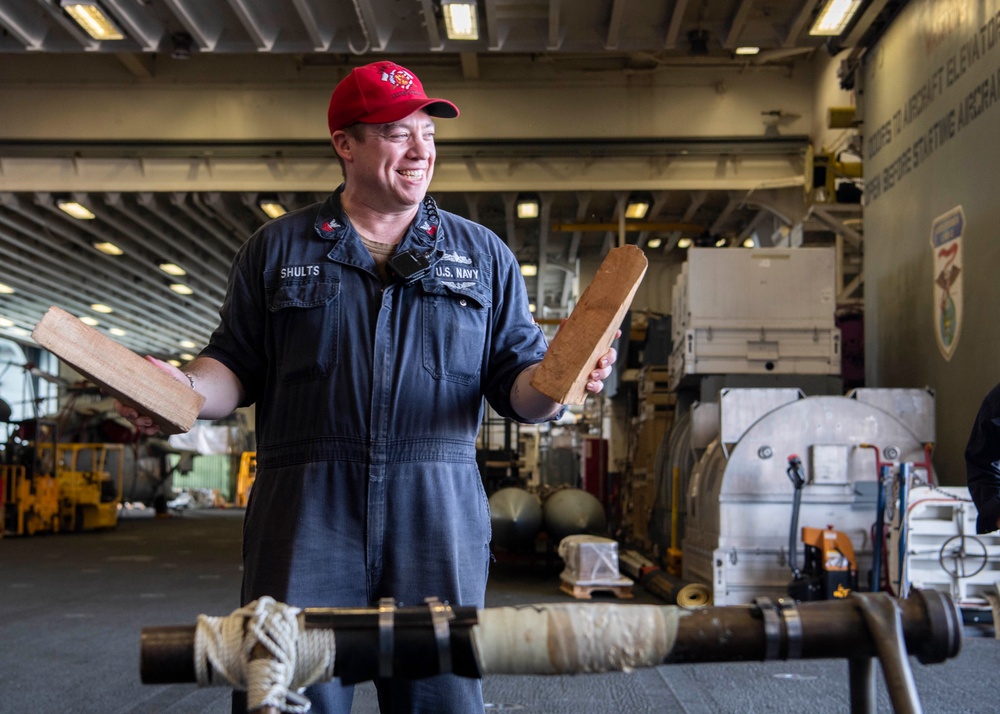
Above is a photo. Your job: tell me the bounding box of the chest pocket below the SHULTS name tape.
[265,271,340,383]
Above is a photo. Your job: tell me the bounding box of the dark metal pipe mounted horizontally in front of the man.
[140,590,962,684]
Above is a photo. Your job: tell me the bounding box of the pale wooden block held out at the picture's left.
[31,307,205,434]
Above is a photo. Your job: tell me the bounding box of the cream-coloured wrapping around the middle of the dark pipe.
[472,604,679,674]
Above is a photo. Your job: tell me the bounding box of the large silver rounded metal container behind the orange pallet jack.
[682,389,934,605]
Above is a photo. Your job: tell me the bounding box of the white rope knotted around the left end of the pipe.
[194,597,336,714]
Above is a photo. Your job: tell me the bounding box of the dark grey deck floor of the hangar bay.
[0,510,1000,714]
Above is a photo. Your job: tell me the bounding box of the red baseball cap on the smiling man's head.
[327,62,458,134]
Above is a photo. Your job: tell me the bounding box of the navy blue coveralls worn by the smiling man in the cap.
[202,188,546,713]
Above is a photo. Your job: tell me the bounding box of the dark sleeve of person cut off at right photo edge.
[965,384,1000,533]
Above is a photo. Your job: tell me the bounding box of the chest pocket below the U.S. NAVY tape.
[423,281,491,384]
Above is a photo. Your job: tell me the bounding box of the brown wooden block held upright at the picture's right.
[531,245,648,404]
